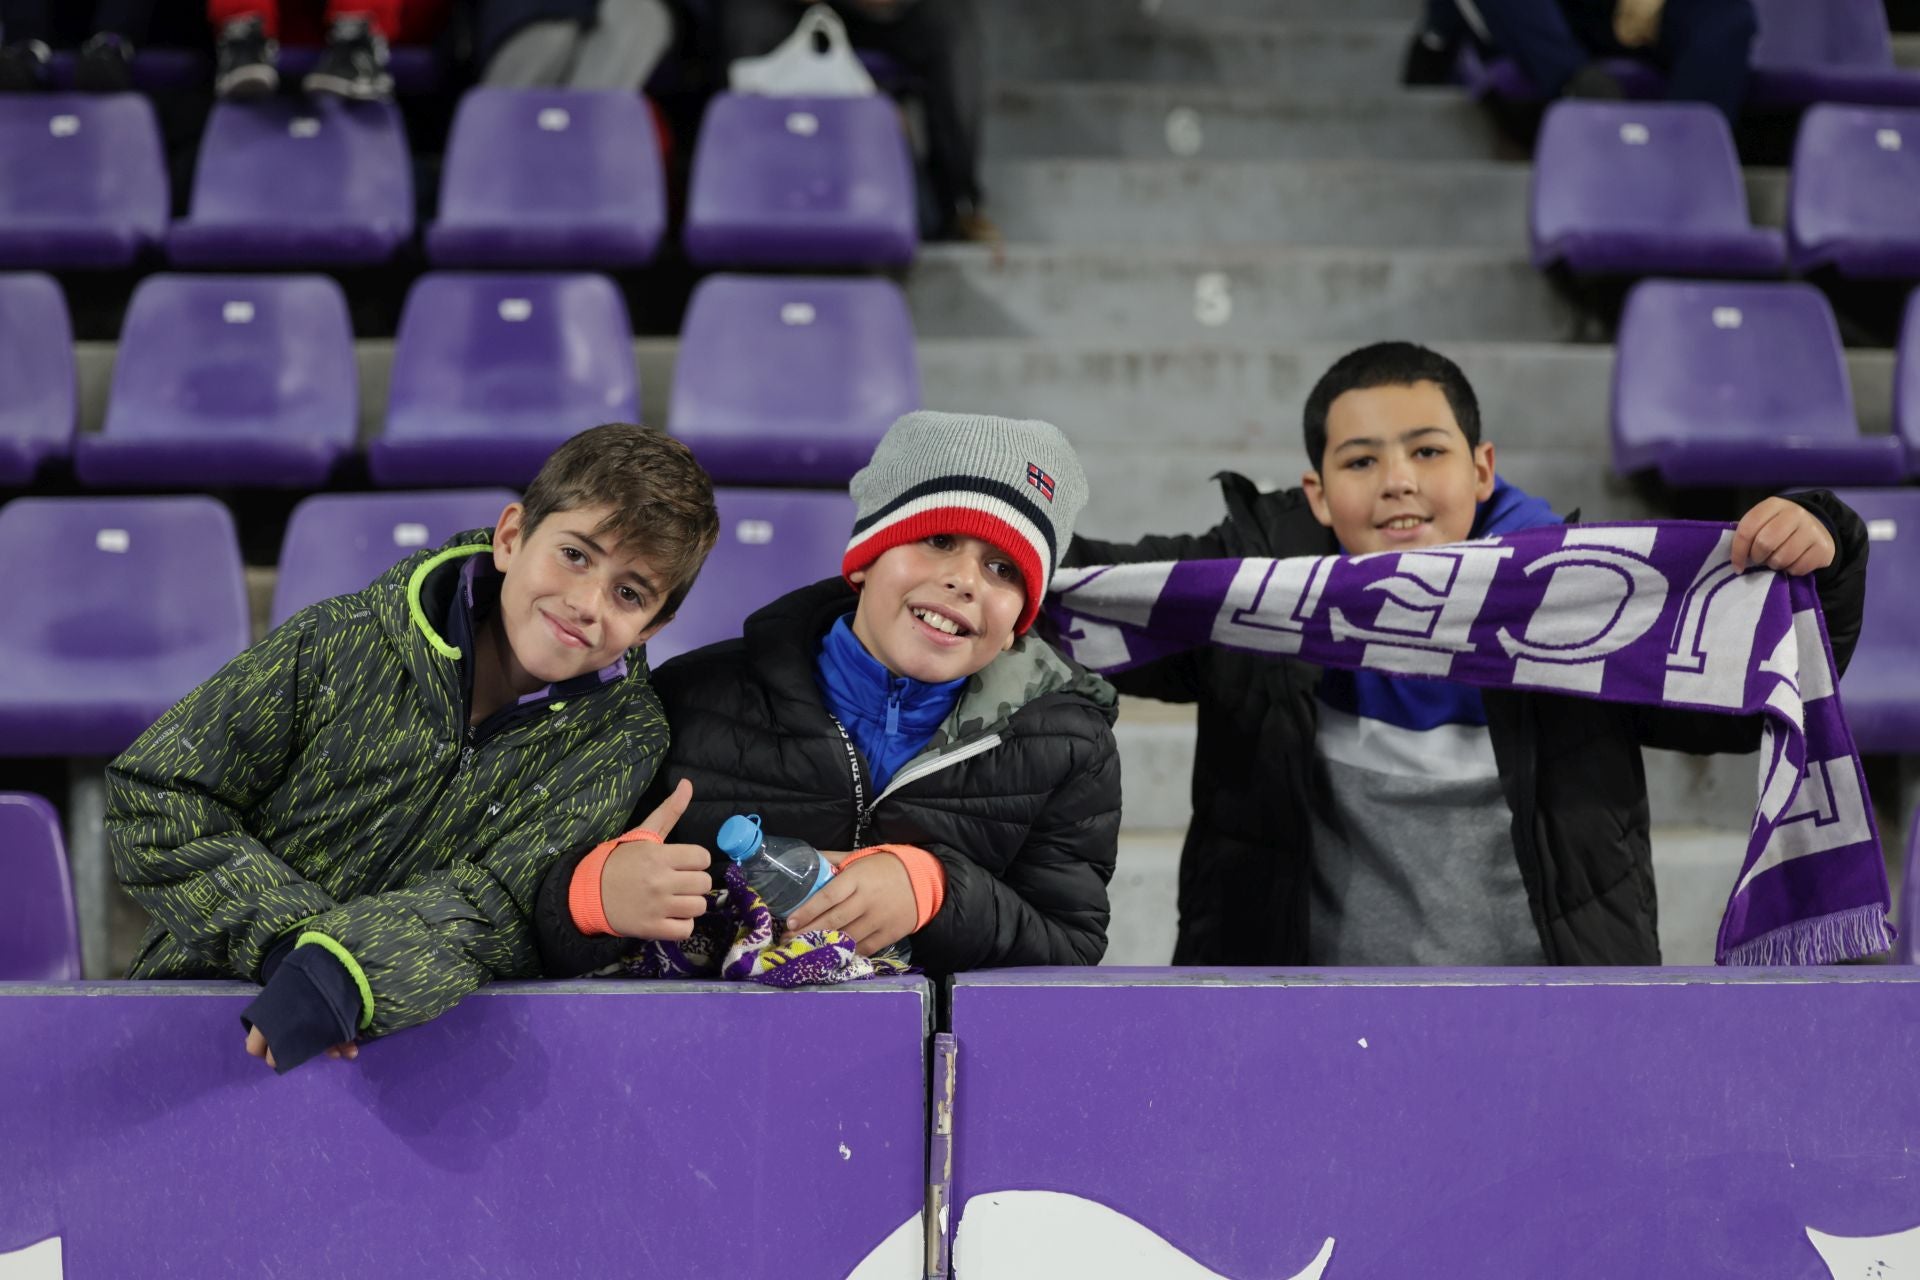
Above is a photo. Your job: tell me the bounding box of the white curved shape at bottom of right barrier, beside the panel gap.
[944,1192,1334,1280]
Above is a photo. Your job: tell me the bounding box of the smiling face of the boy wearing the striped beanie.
[849,533,1027,683]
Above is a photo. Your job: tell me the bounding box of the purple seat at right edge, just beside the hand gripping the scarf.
[1837,489,1920,756]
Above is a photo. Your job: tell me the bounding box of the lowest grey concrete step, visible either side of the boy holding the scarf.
[1102,825,1745,965]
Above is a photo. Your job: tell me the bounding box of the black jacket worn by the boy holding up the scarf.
[1068,474,1866,965]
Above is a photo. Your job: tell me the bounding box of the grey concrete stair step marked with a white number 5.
[906,246,1578,344]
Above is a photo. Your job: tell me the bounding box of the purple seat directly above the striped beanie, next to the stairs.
[666,274,920,486]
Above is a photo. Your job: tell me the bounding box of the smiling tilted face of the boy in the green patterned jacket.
[493,503,672,695]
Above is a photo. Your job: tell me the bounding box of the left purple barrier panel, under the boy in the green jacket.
[0,979,931,1280]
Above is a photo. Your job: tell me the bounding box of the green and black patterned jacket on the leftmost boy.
[108,530,666,1036]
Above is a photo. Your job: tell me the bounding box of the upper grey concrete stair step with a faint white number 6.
[981,73,1528,163]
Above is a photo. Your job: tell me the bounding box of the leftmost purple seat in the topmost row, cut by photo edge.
[0,94,167,269]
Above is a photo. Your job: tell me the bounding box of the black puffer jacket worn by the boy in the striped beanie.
[538,578,1119,977]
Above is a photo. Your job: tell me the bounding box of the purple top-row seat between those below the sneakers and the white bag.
[426,88,666,269]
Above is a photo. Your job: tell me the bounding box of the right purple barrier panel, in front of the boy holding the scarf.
[952,967,1920,1280]
